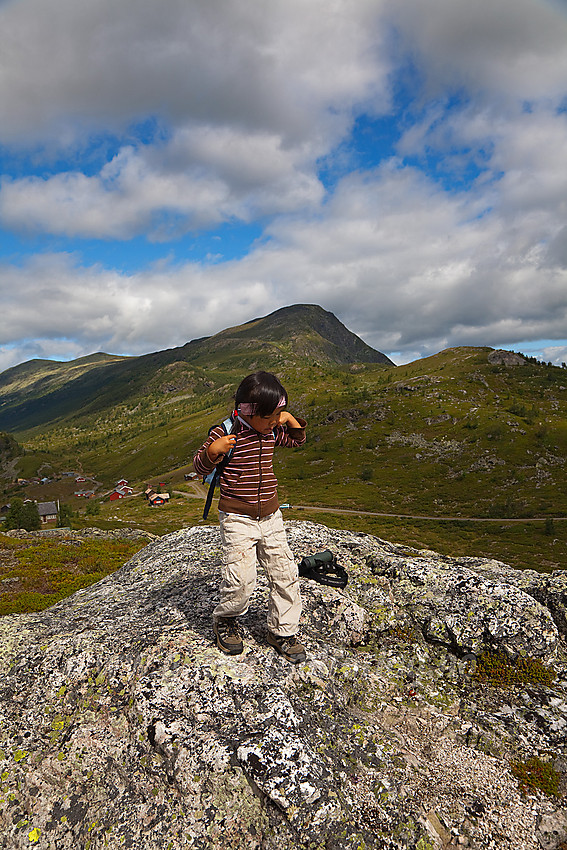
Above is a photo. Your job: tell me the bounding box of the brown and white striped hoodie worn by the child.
[193,418,307,519]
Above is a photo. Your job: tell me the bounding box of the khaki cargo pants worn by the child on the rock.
[213,510,301,637]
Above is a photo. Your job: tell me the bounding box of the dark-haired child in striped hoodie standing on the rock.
[193,372,307,664]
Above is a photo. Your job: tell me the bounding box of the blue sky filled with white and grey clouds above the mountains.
[0,0,567,370]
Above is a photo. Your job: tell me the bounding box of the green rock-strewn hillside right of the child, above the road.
[272,348,567,518]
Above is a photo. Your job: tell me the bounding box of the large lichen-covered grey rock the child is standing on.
[0,522,567,850]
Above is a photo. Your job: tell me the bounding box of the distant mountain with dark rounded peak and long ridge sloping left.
[0,304,393,434]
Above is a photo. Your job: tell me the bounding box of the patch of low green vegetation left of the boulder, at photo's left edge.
[0,534,145,615]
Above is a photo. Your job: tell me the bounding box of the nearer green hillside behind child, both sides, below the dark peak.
[7,348,567,517]
